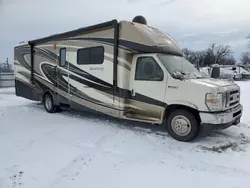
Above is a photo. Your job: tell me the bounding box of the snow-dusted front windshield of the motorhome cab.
[157,54,204,78]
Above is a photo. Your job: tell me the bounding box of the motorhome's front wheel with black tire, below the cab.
[166,109,200,142]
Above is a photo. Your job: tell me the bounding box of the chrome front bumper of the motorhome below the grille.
[200,105,243,128]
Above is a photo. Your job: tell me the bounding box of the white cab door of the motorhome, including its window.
[130,56,167,121]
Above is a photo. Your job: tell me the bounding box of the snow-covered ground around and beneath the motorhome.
[0,81,250,188]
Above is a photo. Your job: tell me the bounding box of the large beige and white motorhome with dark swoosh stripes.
[14,16,243,141]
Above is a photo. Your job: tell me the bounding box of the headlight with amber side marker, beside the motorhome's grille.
[205,93,227,111]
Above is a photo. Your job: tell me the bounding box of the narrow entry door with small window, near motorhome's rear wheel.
[56,45,69,105]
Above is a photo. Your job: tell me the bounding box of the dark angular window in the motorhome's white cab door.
[135,57,163,81]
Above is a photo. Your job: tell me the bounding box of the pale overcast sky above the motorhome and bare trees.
[0,0,250,62]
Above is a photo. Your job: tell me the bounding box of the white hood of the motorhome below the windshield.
[190,78,235,87]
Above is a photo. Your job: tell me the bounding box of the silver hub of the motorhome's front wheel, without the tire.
[171,115,191,136]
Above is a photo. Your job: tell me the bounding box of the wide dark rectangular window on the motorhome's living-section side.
[77,46,104,65]
